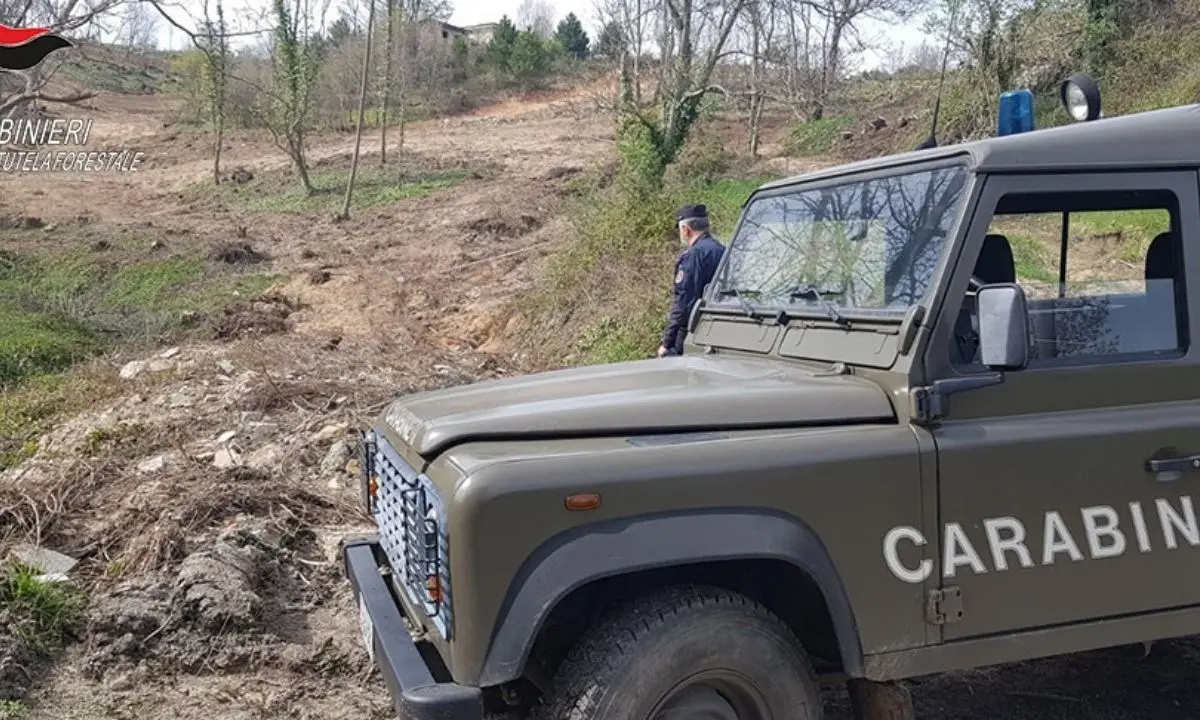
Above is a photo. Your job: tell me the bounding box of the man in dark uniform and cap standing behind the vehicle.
[659,205,725,358]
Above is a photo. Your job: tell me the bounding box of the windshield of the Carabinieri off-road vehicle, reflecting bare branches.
[714,166,967,316]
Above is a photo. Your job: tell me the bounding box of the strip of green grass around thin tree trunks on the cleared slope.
[193,165,470,214]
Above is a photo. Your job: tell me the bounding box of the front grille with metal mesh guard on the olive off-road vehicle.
[368,434,452,640]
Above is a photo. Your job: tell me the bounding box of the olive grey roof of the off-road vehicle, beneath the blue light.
[760,104,1200,190]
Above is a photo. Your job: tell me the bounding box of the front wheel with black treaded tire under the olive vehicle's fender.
[533,586,822,720]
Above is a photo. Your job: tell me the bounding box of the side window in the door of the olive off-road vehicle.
[950,191,1188,367]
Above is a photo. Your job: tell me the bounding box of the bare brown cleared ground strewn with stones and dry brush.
[0,81,1200,720]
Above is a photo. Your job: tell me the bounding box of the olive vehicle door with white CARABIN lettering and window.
[925,170,1200,640]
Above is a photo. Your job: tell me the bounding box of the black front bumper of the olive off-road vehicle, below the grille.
[342,538,484,720]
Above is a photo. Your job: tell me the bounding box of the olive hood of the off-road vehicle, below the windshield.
[384,355,895,456]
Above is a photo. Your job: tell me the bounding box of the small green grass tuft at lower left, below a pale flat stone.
[0,565,86,655]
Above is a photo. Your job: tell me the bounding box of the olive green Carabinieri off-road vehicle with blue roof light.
[344,78,1200,720]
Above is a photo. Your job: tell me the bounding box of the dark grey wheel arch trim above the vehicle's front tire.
[479,508,864,686]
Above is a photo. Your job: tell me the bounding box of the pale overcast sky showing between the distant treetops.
[158,0,925,70]
